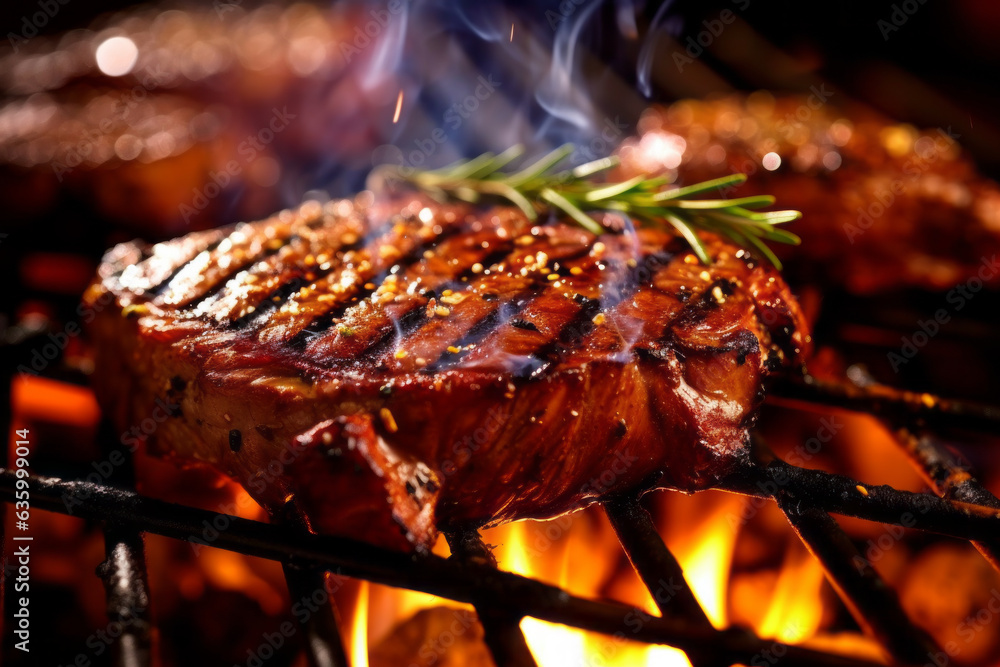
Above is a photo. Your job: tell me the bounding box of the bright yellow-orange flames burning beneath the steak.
[340,492,877,667]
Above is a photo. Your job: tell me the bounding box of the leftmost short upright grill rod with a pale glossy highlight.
[97,421,154,667]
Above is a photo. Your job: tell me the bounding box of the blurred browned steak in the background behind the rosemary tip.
[619,91,1000,294]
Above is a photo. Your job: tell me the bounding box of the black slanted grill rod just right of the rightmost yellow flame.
[753,437,940,665]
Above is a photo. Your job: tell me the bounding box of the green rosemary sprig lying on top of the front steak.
[369,144,802,269]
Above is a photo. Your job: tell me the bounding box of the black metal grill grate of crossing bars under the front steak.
[0,370,1000,667]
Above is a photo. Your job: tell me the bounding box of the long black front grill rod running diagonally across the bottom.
[0,469,878,667]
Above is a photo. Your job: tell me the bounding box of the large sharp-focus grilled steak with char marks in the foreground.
[85,199,808,549]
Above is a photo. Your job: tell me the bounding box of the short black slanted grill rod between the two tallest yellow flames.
[604,497,730,667]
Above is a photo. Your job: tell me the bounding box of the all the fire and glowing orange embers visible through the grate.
[7,366,1000,667]
